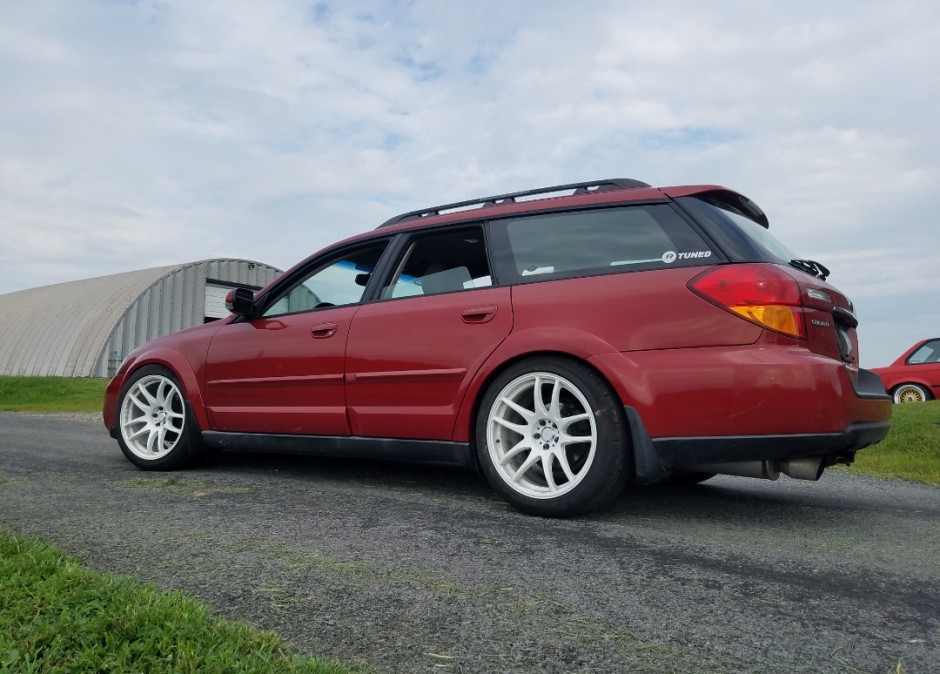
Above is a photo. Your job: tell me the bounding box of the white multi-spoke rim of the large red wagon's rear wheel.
[486,372,598,499]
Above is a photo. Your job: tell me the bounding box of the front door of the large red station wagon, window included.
[205,240,387,436]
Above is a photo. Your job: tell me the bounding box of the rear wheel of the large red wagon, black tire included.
[476,356,630,517]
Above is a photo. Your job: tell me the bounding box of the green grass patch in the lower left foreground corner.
[0,529,351,674]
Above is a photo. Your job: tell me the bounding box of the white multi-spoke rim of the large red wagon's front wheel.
[119,374,186,461]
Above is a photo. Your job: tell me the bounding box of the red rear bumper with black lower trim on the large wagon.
[593,346,892,483]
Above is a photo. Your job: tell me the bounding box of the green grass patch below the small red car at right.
[846,400,940,484]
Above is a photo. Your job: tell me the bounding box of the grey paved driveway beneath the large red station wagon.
[0,413,940,674]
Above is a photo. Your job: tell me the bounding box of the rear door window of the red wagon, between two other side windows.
[382,226,493,299]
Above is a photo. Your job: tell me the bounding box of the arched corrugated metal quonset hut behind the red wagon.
[0,259,281,377]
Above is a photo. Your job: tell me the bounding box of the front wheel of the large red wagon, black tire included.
[117,365,210,470]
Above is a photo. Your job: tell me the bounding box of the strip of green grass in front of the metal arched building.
[0,376,108,412]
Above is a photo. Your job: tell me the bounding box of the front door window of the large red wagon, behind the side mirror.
[262,241,388,318]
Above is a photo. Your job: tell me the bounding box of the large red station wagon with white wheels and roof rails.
[104,179,891,516]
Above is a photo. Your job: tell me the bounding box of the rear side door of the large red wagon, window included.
[346,226,512,440]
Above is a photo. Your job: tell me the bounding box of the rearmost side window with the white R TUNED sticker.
[492,204,716,283]
